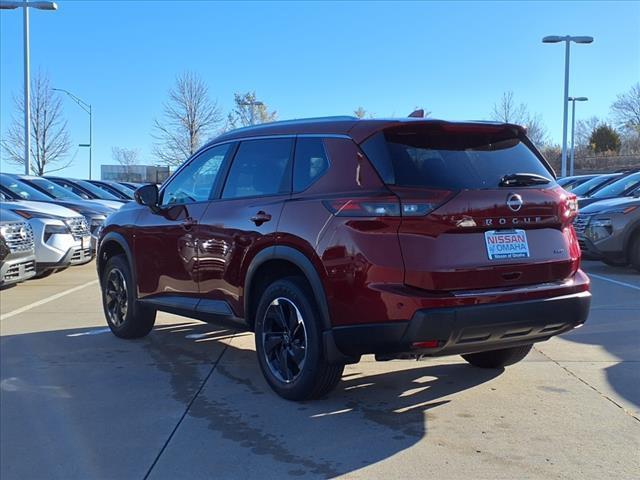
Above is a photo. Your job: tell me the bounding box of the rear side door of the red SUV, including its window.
[197,138,294,315]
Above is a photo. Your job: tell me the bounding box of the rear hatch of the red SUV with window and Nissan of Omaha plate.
[362,122,579,291]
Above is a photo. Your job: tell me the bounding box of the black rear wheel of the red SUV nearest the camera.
[255,277,344,401]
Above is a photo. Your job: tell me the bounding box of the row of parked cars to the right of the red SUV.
[558,169,640,271]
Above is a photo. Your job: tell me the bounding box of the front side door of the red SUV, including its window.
[134,144,233,299]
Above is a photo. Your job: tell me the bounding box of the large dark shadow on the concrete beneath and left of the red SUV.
[0,323,501,478]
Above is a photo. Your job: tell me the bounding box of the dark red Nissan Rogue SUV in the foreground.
[98,117,591,400]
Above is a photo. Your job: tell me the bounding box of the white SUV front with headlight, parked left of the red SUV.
[0,199,95,277]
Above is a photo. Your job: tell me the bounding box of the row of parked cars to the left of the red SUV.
[0,173,139,287]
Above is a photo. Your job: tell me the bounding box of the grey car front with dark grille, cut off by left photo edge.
[0,209,36,287]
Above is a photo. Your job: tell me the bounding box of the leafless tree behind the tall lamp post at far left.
[1,72,73,175]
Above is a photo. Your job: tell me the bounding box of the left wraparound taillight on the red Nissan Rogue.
[322,197,448,217]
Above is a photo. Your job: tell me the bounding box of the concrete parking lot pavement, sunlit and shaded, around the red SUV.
[0,262,640,480]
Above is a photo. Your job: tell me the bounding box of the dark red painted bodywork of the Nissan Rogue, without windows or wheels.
[103,119,589,340]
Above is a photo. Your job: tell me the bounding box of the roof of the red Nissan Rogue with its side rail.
[207,116,524,145]
